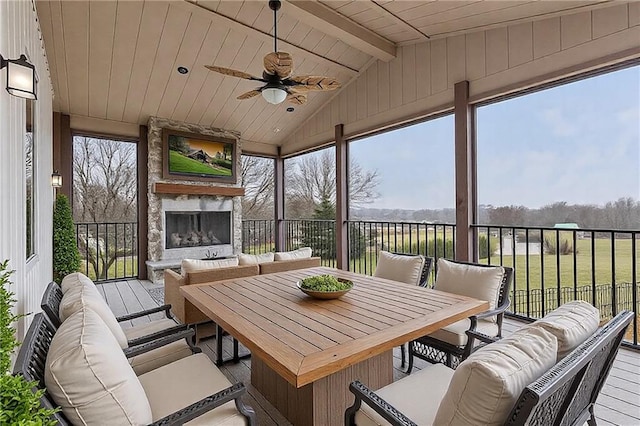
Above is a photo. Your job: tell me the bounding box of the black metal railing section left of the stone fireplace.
[75,222,138,281]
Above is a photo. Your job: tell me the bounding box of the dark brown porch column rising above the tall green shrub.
[53,112,73,201]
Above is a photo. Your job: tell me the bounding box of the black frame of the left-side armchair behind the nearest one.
[40,281,188,347]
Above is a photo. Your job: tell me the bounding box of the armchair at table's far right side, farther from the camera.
[373,251,433,367]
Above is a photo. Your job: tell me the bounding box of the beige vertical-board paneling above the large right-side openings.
[282,2,640,155]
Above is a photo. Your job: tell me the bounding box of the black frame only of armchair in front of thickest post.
[406,259,513,374]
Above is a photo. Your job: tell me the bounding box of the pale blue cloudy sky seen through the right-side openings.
[350,66,640,209]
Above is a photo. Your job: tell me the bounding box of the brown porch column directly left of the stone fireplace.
[136,126,149,280]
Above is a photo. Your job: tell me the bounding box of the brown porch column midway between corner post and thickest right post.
[335,124,349,270]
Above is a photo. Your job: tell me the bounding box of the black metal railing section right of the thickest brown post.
[474,225,640,347]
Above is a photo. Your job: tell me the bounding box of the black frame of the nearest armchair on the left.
[14,313,256,426]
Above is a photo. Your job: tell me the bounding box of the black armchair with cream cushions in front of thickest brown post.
[407,259,513,374]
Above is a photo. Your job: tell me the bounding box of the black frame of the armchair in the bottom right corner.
[345,311,634,426]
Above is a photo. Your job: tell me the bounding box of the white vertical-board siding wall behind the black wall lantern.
[0,0,53,339]
